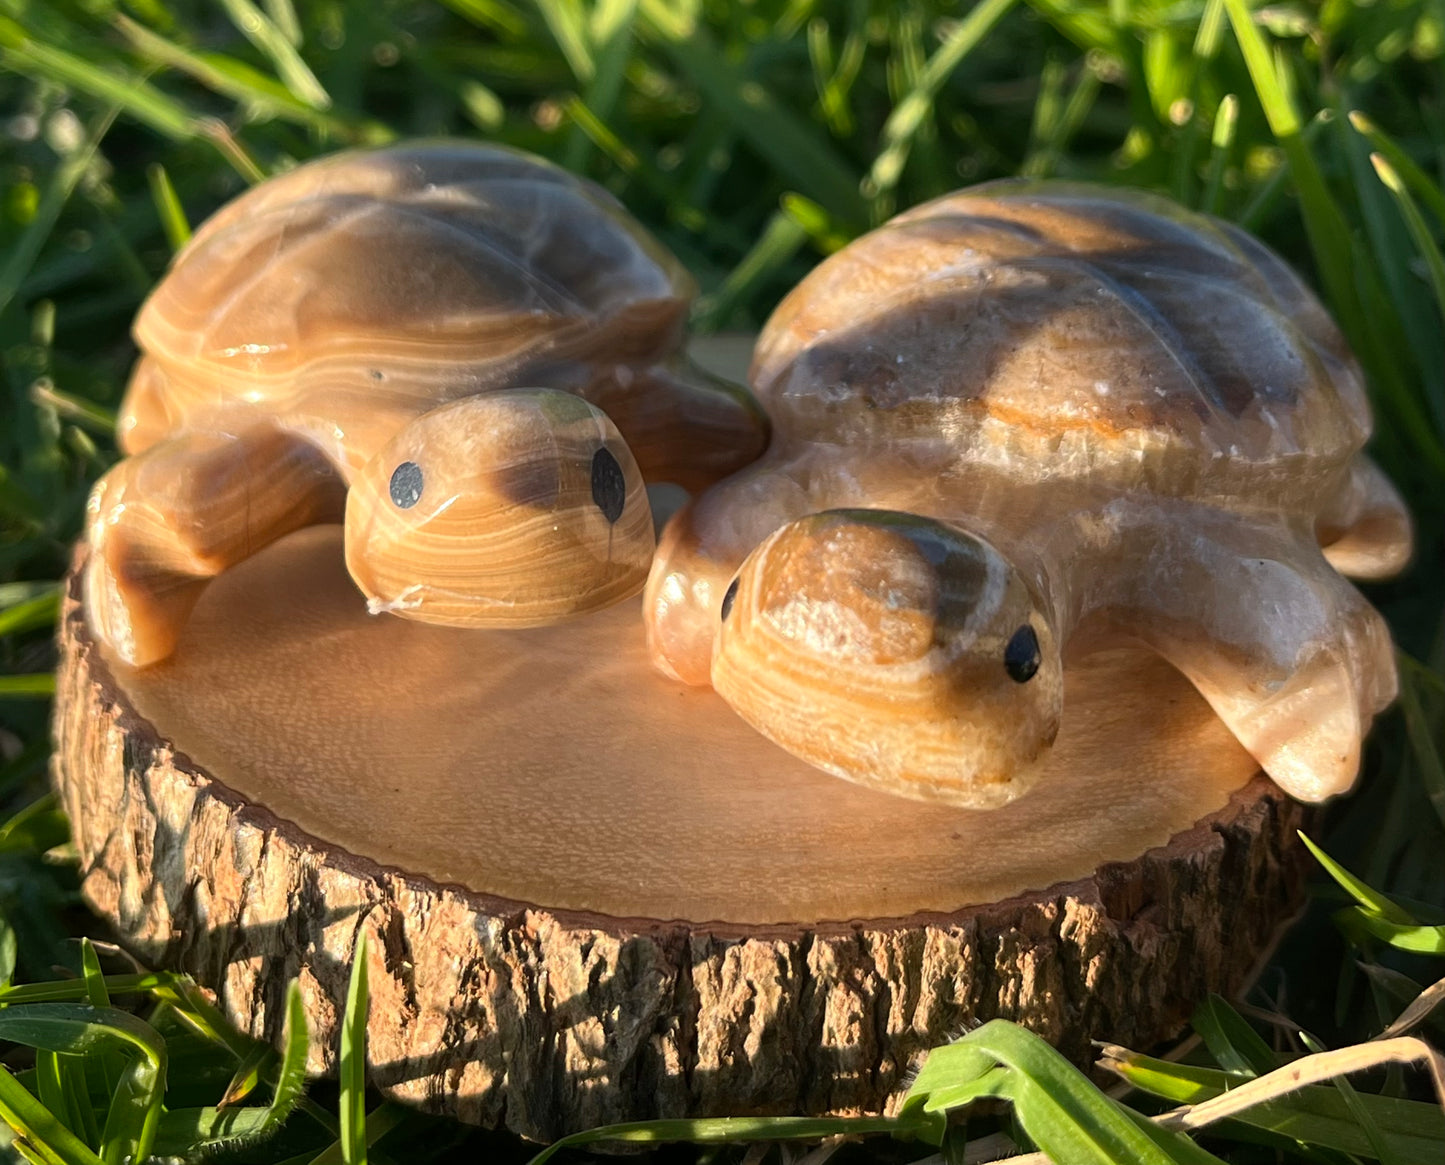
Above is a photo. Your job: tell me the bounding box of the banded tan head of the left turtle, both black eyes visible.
[345,389,653,627]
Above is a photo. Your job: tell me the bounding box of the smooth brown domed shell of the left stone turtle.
[136,142,695,448]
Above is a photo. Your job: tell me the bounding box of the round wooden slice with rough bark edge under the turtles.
[56,528,1302,1139]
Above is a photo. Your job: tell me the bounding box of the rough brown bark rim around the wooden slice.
[55,546,1303,1139]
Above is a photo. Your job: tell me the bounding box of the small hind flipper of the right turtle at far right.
[1315,454,1413,578]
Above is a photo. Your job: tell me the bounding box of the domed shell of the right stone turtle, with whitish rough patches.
[751,182,1370,499]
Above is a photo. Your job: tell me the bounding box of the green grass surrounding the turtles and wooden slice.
[0,0,1445,1162]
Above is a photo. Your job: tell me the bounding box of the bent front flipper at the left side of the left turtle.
[82,425,345,666]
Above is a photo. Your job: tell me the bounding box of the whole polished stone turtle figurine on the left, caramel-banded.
[84,142,767,666]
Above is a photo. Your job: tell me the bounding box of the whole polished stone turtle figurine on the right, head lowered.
[644,182,1410,808]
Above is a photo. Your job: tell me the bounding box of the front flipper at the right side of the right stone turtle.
[1107,512,1396,801]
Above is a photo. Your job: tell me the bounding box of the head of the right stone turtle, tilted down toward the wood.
[712,510,1064,808]
